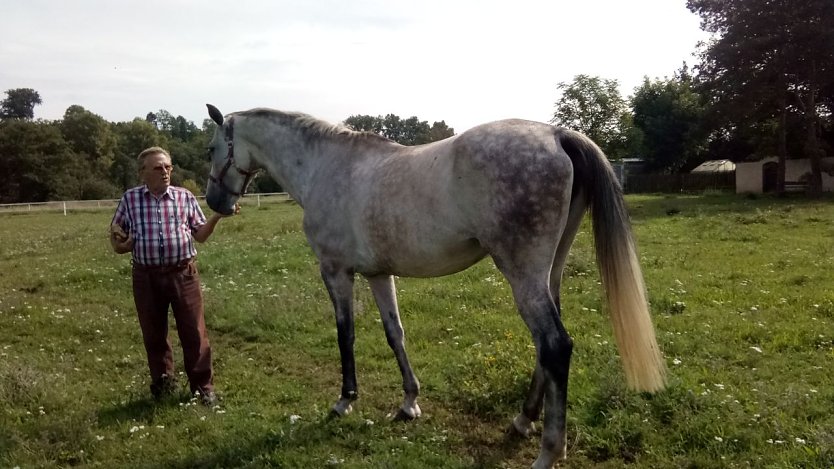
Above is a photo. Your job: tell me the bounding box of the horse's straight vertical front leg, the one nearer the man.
[321,262,359,417]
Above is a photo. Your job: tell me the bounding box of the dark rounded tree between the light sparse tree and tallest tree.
[631,66,706,172]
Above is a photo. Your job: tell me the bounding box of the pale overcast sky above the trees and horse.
[0,0,709,133]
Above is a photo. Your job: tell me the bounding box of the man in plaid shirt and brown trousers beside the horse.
[110,147,239,406]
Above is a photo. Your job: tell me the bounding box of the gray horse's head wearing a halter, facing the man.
[206,104,257,215]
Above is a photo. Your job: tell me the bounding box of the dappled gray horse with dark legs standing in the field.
[206,105,665,468]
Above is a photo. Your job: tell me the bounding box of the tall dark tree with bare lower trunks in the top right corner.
[687,0,834,193]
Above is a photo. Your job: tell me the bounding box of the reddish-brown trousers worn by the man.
[133,260,214,393]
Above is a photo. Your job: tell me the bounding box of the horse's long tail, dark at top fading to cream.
[557,129,666,392]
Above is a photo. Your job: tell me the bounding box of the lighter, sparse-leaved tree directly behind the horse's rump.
[551,75,631,159]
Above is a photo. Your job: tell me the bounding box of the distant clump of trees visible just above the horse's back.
[344,114,455,145]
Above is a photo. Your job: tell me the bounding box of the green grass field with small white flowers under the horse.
[0,195,834,468]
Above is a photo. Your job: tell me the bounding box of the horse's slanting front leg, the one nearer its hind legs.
[368,275,421,420]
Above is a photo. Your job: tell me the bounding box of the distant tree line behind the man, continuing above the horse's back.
[0,97,454,203]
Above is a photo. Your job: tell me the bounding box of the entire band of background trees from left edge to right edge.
[0,0,834,203]
